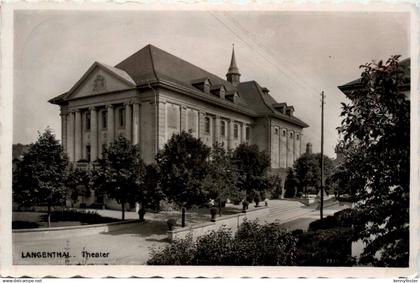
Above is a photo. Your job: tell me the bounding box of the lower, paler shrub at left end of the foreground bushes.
[147,234,196,265]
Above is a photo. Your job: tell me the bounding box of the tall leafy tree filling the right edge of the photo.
[338,56,410,267]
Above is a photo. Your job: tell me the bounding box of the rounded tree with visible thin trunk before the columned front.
[93,136,145,220]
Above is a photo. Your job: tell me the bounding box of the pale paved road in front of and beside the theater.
[13,200,345,265]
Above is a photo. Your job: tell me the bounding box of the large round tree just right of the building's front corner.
[156,132,210,208]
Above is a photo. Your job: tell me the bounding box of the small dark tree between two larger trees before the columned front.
[64,165,91,209]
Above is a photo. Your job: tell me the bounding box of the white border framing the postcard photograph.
[0,0,420,278]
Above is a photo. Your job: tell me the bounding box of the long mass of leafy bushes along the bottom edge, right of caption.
[147,220,296,265]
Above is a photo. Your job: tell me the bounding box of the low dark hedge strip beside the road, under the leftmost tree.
[42,210,119,224]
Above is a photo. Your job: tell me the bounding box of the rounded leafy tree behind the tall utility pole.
[293,153,334,195]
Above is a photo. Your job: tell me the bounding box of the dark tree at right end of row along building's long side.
[233,143,271,201]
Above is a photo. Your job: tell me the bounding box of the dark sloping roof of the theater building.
[50,44,308,127]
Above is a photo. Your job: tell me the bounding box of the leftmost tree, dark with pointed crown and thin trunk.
[13,128,68,227]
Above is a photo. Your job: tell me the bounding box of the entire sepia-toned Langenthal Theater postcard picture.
[1,5,418,277]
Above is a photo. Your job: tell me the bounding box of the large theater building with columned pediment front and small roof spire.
[49,45,308,178]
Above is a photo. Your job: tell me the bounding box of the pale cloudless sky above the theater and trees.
[13,10,410,157]
